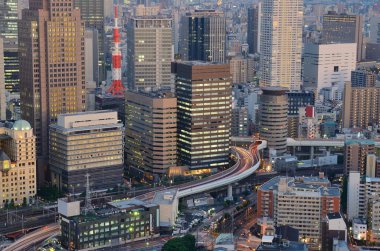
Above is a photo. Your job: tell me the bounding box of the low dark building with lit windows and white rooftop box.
[58,199,160,250]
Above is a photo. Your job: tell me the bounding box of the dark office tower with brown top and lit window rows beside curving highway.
[172,61,232,170]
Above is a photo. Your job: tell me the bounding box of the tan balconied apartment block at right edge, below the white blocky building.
[342,82,380,129]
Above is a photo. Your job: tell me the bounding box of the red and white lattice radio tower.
[107,6,125,96]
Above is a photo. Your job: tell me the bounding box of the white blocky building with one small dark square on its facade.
[303,43,356,93]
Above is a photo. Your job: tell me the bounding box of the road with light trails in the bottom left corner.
[4,223,60,251]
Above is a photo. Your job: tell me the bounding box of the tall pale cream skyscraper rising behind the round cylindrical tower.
[260,0,303,90]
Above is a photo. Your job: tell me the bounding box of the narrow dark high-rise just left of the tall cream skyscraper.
[247,3,261,54]
